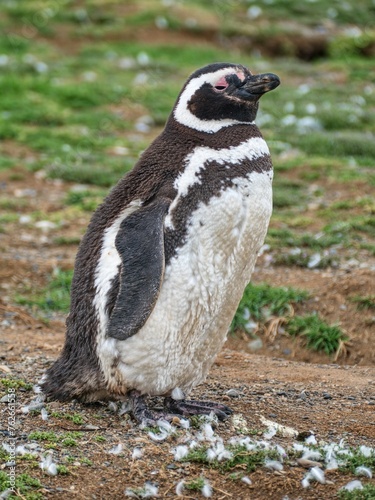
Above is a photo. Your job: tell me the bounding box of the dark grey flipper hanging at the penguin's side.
[107,198,171,340]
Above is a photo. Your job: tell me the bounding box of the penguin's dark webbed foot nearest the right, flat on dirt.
[164,397,233,420]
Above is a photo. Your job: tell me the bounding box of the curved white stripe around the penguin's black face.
[173,67,254,134]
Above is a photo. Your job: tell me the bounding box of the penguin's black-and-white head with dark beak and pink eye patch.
[173,63,280,133]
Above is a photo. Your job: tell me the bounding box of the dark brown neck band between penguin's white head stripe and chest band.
[163,114,262,149]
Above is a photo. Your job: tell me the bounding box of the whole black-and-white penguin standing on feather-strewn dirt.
[41,63,280,422]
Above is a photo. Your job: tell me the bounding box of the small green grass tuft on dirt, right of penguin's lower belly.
[286,314,348,355]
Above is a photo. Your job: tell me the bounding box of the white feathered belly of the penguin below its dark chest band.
[112,172,272,395]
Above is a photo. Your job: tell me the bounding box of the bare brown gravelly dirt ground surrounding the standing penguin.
[0,163,375,500]
